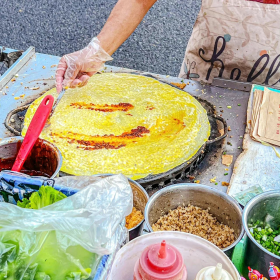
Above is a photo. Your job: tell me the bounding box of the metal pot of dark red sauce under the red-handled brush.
[0,136,62,178]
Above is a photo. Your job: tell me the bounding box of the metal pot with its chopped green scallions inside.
[242,191,280,277]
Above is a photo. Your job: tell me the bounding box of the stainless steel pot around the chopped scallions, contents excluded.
[242,191,280,279]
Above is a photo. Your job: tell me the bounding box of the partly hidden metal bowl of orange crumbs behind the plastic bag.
[91,174,149,240]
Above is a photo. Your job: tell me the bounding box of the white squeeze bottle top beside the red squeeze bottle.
[195,263,233,280]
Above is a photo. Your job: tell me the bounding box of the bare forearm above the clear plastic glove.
[97,0,157,55]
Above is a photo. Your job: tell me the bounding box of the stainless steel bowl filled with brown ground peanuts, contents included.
[145,183,244,258]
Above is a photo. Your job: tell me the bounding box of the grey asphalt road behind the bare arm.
[0,0,200,76]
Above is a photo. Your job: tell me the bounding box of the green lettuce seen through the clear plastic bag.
[0,230,98,280]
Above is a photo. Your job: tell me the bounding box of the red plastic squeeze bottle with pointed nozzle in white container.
[133,241,187,280]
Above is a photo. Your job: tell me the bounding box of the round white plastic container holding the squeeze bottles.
[108,231,240,280]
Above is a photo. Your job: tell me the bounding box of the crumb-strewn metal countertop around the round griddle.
[0,46,249,195]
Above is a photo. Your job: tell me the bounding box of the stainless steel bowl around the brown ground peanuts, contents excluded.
[145,183,244,258]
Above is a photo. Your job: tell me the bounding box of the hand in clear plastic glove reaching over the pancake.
[55,37,112,93]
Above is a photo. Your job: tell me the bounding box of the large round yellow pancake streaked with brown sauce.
[22,73,210,179]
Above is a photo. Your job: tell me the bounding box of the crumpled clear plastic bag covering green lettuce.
[0,175,133,280]
